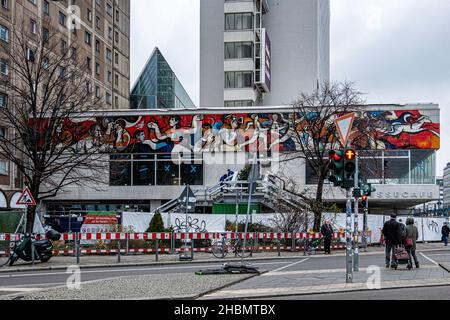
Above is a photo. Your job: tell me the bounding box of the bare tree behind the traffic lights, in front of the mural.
[279,82,376,232]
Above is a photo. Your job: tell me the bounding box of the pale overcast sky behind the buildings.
[131,0,450,175]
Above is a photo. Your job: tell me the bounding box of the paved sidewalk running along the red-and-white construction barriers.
[0,243,450,273]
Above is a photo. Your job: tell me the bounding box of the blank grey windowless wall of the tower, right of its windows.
[264,0,329,105]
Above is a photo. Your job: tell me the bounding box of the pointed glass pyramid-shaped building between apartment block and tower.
[131,48,195,109]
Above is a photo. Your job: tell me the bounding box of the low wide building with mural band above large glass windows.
[37,105,440,218]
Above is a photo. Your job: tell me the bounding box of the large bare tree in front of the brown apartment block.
[0,25,101,232]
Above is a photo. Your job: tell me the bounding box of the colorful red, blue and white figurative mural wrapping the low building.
[42,110,440,153]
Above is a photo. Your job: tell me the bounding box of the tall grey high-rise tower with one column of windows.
[200,0,330,108]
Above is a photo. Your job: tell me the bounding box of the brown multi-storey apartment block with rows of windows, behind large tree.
[0,0,130,206]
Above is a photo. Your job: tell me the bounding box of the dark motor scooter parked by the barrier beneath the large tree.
[7,229,61,266]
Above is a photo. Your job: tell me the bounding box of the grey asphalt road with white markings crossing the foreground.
[0,251,450,299]
